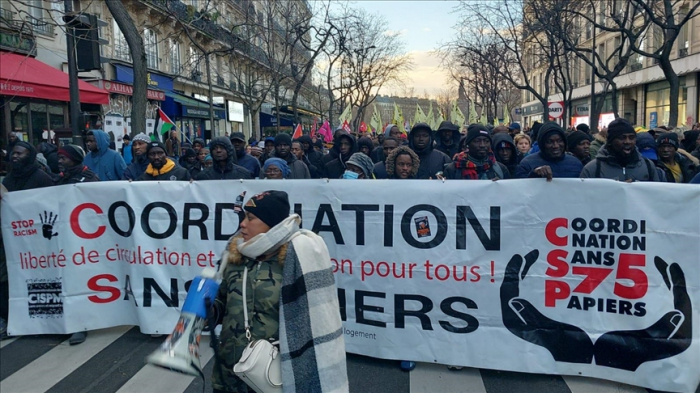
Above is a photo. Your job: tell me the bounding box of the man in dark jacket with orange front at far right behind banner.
[656,132,696,183]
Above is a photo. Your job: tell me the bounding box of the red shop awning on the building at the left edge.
[0,52,109,105]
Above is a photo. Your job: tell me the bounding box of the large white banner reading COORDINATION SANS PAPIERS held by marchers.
[2,179,700,391]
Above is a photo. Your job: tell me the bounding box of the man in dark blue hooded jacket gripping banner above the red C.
[515,121,584,181]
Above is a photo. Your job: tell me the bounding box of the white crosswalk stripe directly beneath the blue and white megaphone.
[117,337,214,393]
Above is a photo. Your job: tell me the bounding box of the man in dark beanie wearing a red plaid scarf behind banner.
[448,124,510,180]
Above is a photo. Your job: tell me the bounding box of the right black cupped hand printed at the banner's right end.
[595,257,693,371]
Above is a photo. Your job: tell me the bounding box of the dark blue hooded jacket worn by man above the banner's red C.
[515,123,583,179]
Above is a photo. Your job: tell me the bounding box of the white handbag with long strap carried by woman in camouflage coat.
[233,268,282,393]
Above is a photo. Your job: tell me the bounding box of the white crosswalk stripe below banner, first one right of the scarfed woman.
[411,363,486,393]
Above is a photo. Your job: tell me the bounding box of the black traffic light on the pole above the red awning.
[63,13,108,71]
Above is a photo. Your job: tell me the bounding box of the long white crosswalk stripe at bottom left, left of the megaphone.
[2,326,130,393]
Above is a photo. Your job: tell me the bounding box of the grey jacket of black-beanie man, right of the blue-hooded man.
[581,146,660,182]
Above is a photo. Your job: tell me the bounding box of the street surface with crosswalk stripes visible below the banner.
[0,326,700,393]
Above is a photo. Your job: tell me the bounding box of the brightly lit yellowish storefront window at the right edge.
[644,79,688,127]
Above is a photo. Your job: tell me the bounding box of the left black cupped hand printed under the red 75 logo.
[501,250,593,363]
